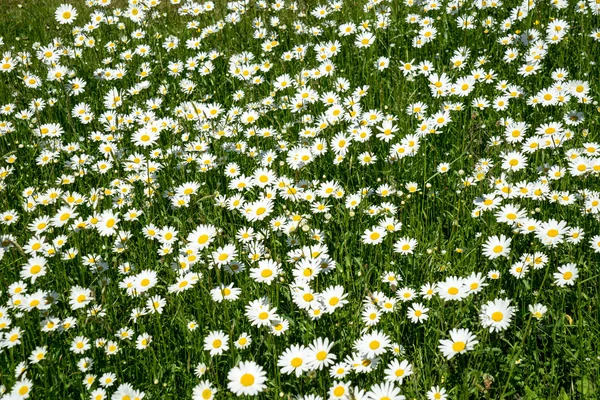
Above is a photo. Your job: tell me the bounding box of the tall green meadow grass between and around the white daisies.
[0,0,600,399]
